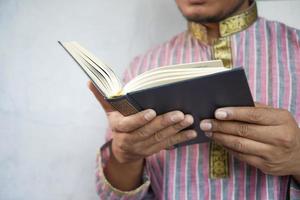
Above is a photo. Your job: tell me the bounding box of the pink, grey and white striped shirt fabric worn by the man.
[97,18,300,200]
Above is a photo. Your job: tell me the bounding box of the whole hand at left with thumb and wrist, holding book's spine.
[89,82,197,191]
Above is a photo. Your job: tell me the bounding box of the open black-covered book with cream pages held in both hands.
[59,42,254,146]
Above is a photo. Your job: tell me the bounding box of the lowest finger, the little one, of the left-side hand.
[147,130,197,155]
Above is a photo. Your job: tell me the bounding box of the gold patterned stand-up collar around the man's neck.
[188,1,257,43]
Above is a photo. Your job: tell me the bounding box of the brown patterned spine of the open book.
[107,95,140,116]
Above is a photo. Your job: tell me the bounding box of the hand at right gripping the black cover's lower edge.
[200,104,300,182]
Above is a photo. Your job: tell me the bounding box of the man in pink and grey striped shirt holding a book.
[89,0,300,199]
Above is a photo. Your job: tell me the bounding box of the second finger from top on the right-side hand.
[200,119,282,144]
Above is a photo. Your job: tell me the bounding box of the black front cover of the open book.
[107,67,254,146]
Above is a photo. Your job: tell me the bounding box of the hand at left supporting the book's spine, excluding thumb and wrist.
[108,109,196,163]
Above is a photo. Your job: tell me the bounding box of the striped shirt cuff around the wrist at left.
[96,141,150,199]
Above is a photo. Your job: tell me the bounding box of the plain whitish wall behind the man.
[0,0,300,200]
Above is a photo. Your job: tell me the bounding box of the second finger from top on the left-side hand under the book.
[132,111,184,143]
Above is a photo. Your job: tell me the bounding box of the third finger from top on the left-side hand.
[140,115,194,147]
